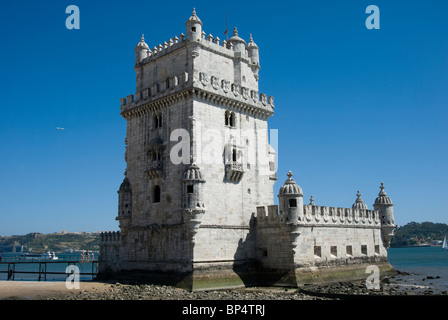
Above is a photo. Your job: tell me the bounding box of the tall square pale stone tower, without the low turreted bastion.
[102,10,276,289]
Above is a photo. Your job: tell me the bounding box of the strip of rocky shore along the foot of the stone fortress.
[41,275,448,300]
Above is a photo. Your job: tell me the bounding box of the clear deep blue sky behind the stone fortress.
[0,0,448,235]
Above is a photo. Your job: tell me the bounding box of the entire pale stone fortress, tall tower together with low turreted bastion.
[100,11,395,290]
